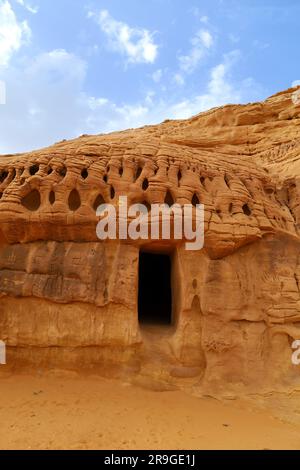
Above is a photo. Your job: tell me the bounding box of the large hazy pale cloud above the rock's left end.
[0,50,87,153]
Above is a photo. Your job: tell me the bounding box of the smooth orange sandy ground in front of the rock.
[0,374,300,450]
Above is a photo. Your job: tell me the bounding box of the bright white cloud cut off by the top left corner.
[0,0,31,66]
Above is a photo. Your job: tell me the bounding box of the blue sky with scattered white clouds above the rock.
[0,0,300,153]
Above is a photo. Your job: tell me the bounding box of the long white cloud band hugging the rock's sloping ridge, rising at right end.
[81,51,261,133]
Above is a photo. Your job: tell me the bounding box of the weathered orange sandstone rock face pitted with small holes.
[0,88,300,390]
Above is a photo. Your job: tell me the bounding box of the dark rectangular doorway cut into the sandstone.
[139,253,172,325]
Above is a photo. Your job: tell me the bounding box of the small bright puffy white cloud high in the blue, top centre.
[88,10,158,64]
